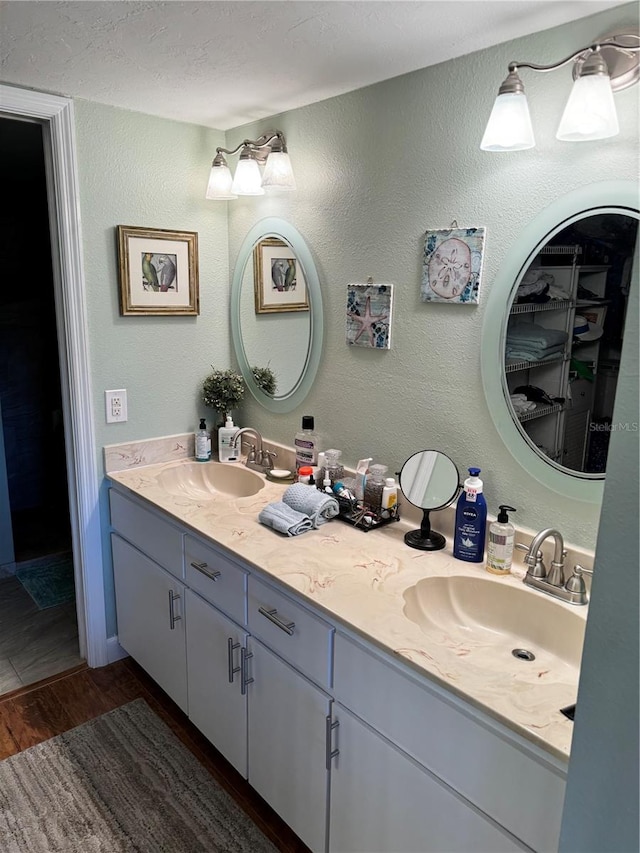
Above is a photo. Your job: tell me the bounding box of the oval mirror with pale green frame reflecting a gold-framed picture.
[231,217,323,413]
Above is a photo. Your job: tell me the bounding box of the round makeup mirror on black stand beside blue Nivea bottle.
[400,450,460,551]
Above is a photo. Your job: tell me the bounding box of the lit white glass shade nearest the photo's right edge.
[556,74,620,142]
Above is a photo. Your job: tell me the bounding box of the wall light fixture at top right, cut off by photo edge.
[480,32,640,151]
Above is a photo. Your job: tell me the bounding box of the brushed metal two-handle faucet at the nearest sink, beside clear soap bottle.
[516,527,592,604]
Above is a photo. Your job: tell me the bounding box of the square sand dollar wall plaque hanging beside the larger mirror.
[420,222,485,305]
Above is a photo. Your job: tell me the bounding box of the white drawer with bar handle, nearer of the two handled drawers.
[248,575,333,687]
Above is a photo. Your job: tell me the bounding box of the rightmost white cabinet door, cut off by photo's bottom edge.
[329,704,529,853]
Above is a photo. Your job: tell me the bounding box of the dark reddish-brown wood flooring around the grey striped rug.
[0,658,310,853]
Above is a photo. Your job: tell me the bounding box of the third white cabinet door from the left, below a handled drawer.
[248,638,330,853]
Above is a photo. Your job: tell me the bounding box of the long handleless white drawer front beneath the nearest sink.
[334,634,566,851]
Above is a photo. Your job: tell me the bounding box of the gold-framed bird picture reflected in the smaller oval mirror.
[253,237,309,314]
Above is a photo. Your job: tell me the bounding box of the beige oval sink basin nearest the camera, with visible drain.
[404,575,585,677]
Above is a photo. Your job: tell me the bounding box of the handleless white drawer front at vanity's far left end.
[109,489,184,579]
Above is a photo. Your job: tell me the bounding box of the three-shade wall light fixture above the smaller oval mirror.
[206,130,296,200]
